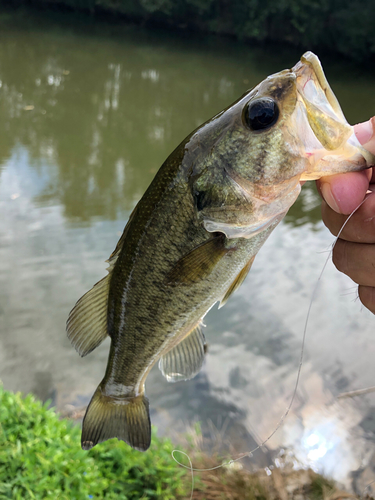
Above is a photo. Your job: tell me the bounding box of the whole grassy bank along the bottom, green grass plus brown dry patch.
[0,385,370,500]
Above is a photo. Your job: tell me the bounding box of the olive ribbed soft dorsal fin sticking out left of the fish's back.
[66,274,111,357]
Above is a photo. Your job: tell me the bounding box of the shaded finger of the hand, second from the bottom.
[332,239,375,287]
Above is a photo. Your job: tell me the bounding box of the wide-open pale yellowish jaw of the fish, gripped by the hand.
[291,52,375,181]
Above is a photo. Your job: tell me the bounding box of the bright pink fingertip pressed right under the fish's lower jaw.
[317,170,371,215]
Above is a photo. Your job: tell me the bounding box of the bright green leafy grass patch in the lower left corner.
[0,385,189,500]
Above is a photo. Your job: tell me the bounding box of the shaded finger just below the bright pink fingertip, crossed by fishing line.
[322,186,375,243]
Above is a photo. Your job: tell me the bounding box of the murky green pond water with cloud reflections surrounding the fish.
[0,7,375,491]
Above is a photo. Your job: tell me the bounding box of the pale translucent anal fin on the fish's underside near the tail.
[159,326,205,382]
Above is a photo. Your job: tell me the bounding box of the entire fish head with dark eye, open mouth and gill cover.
[194,52,375,237]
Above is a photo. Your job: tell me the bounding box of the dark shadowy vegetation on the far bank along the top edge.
[0,0,375,60]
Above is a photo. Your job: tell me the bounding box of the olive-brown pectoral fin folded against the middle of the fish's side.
[165,234,233,286]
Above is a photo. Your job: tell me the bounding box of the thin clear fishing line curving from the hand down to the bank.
[172,192,372,500]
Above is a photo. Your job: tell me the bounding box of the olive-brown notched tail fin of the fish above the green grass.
[81,385,151,451]
